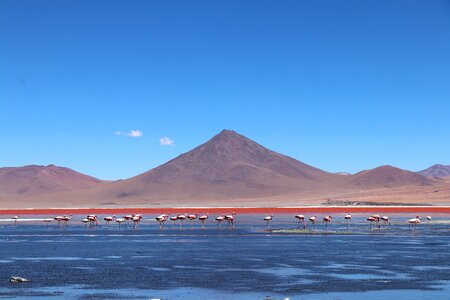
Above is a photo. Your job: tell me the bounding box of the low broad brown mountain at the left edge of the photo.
[0,165,102,197]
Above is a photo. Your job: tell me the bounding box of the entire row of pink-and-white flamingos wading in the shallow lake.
[6,212,432,230]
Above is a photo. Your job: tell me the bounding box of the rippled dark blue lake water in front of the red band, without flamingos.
[0,215,450,299]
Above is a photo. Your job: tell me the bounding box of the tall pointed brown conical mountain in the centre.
[94,130,346,201]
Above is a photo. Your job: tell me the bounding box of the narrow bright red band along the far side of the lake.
[0,206,450,215]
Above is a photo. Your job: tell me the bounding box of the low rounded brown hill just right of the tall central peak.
[348,166,433,189]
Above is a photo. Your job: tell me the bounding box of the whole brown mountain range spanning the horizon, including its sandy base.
[0,130,450,207]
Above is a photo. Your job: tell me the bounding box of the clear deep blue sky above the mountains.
[0,0,450,179]
